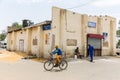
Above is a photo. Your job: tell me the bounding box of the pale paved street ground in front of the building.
[0,50,120,80]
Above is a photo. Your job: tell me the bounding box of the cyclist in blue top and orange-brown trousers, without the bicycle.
[52,45,62,67]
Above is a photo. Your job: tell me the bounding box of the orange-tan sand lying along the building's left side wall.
[0,49,45,63]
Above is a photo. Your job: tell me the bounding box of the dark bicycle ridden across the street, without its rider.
[44,53,68,71]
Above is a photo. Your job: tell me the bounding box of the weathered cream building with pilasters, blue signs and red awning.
[7,7,116,57]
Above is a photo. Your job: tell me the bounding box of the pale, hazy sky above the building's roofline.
[0,0,120,32]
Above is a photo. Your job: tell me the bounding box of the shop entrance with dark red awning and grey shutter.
[87,34,103,56]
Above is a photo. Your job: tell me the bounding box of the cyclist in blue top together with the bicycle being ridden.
[44,46,68,71]
